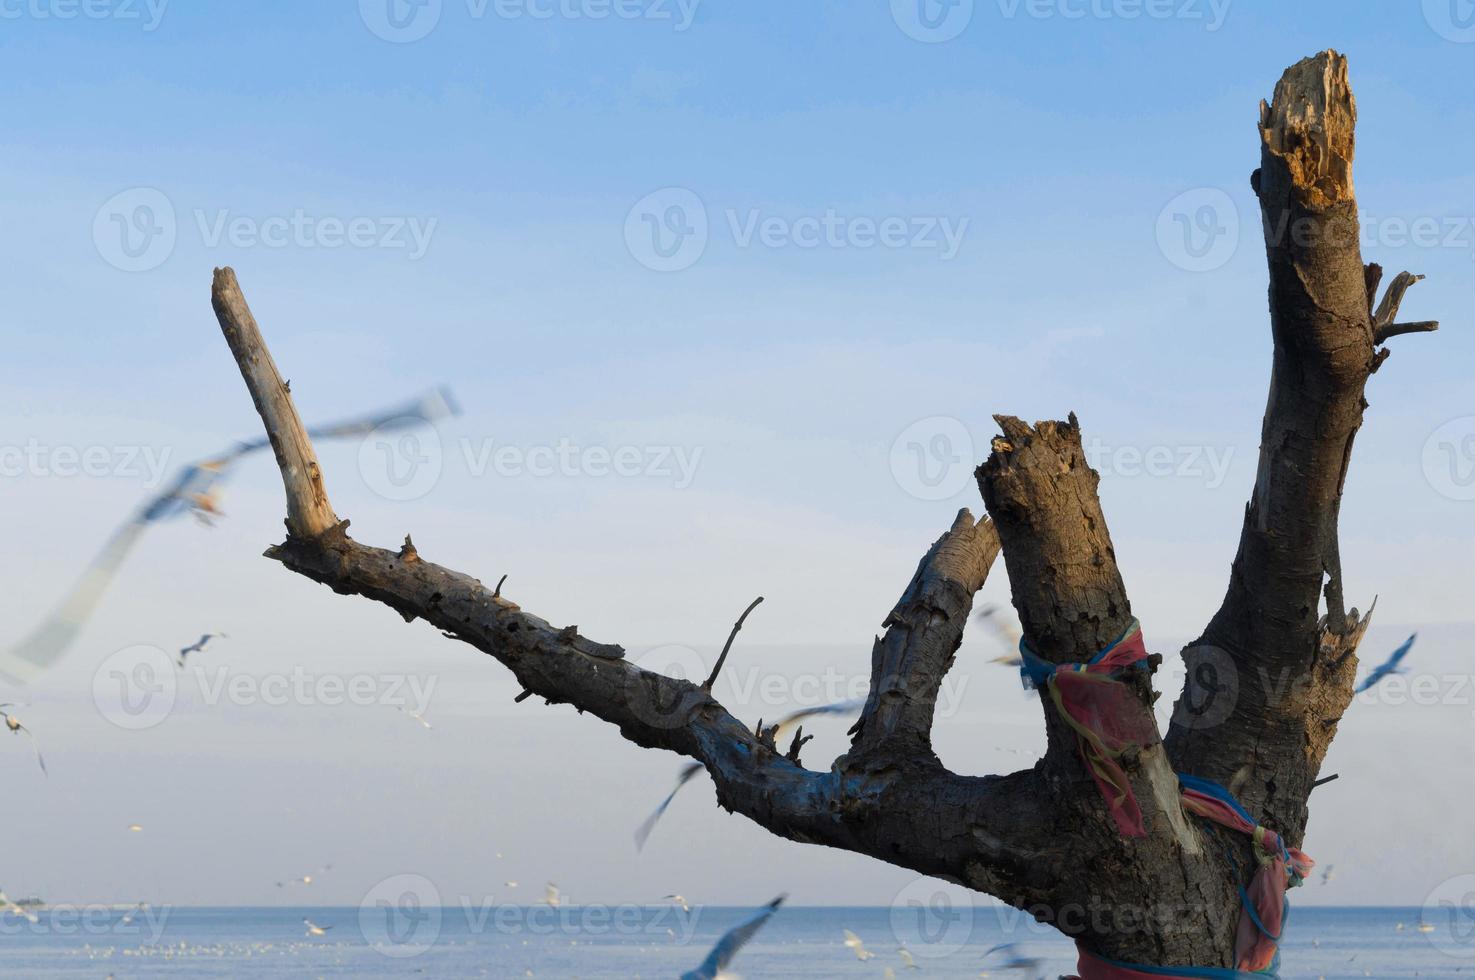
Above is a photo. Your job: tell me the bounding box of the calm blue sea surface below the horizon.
[0,906,1475,980]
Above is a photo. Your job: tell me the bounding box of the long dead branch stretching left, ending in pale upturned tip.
[214,262,1061,905]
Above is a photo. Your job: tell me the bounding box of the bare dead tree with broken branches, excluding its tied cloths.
[212,52,1434,967]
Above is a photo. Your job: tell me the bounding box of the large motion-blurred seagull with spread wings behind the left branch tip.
[0,388,460,683]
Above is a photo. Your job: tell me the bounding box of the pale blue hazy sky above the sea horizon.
[0,0,1475,920]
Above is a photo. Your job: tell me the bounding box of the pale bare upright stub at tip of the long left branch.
[209,269,338,537]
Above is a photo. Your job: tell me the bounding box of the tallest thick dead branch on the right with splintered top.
[1168,52,1435,843]
